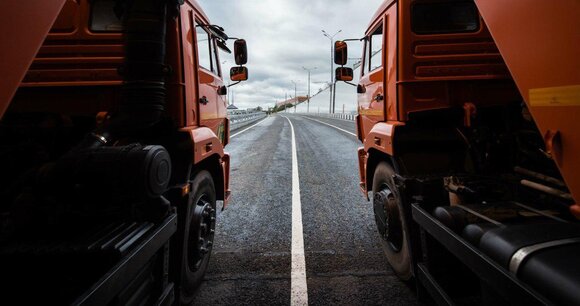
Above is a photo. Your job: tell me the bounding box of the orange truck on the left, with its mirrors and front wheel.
[0,0,248,305]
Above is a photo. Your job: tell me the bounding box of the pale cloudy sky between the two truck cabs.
[198,0,383,112]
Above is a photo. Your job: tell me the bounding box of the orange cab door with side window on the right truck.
[357,18,386,141]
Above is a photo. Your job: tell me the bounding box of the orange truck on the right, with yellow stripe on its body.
[335,0,580,305]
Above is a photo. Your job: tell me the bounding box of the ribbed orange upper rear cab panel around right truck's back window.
[399,0,509,83]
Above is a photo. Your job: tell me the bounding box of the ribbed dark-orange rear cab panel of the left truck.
[20,0,124,88]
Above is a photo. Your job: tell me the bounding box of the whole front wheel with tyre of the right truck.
[373,162,412,280]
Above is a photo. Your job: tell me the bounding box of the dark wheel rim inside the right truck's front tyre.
[373,186,403,252]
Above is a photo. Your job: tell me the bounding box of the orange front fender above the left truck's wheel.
[182,127,230,208]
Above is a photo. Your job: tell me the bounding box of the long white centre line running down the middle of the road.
[282,116,308,306]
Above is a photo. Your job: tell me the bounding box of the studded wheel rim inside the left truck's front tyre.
[188,196,216,271]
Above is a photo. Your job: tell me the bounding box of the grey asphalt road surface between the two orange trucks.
[195,114,417,305]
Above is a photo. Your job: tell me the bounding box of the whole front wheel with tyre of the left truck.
[180,170,216,304]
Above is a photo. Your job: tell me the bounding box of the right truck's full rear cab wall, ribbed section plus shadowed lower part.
[396,0,520,121]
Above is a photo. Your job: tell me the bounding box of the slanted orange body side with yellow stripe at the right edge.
[475,0,580,202]
